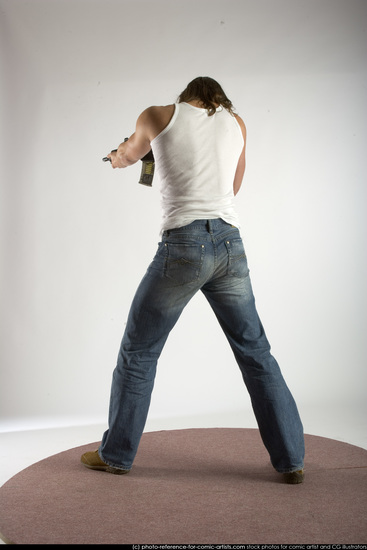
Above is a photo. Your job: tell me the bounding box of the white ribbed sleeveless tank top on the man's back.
[151,103,244,231]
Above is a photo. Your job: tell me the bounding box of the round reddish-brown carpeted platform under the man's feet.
[0,428,367,544]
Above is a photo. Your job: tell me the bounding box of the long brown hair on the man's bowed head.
[177,76,234,116]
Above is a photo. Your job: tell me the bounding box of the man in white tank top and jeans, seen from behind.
[82,77,304,483]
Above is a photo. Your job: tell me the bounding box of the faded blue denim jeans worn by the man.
[99,219,304,472]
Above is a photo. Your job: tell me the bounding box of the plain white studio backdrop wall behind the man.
[0,0,367,436]
